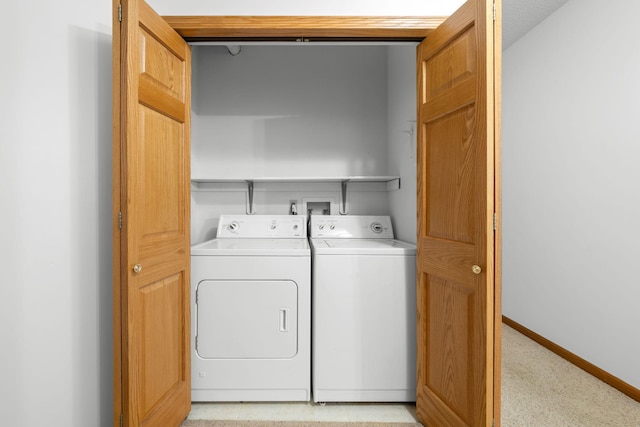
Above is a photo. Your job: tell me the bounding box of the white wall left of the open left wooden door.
[0,0,113,427]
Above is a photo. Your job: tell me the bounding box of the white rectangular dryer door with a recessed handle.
[196,280,298,359]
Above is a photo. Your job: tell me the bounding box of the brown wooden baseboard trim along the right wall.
[502,316,640,402]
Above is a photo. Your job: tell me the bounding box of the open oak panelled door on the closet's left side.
[113,0,191,427]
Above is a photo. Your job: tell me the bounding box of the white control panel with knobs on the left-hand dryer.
[216,215,307,239]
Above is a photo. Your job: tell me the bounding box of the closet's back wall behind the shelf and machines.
[191,44,392,243]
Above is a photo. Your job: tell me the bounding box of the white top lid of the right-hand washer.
[310,239,416,256]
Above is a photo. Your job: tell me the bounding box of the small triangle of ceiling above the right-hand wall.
[502,0,569,50]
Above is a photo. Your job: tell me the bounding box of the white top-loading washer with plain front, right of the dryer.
[310,216,416,402]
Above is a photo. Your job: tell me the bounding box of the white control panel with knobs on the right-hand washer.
[309,215,393,239]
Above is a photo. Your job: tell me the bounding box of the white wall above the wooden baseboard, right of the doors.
[503,0,640,387]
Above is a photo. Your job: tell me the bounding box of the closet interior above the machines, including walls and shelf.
[190,40,417,244]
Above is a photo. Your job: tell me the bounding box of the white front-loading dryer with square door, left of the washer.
[191,215,311,402]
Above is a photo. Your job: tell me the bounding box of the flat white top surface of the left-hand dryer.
[191,239,311,256]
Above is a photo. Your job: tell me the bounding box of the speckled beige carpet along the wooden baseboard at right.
[501,324,640,427]
